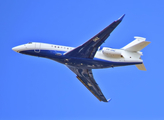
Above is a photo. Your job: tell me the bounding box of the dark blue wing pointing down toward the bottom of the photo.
[67,66,109,102]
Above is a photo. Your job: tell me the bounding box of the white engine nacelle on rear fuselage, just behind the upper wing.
[102,47,122,57]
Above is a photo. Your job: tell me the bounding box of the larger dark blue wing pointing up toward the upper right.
[65,14,125,59]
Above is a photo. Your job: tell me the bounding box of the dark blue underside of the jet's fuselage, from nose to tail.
[21,50,141,69]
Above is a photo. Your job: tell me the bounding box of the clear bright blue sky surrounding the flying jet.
[0,0,164,120]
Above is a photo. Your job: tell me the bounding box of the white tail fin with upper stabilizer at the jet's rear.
[122,37,150,51]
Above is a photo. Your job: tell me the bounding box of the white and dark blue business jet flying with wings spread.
[12,14,150,102]
